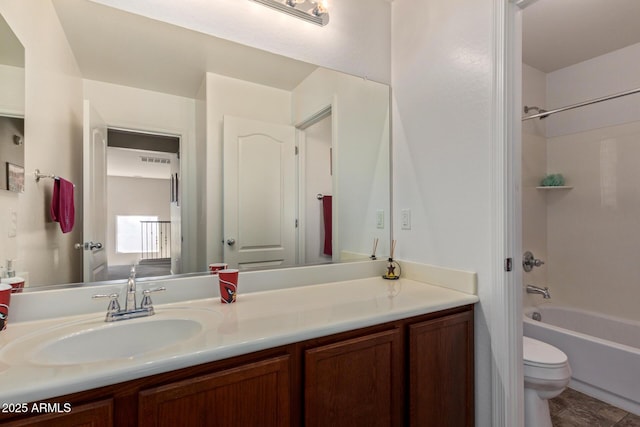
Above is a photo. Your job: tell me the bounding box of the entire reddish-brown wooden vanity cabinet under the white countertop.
[0,305,474,427]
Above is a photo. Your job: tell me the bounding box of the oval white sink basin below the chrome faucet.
[0,309,219,366]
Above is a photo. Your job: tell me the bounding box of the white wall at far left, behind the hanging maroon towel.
[0,0,82,285]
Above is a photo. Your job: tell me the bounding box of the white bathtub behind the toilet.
[523,304,640,415]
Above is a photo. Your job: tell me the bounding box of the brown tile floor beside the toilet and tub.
[549,388,640,427]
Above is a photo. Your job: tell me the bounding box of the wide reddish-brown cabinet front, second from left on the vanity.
[138,356,291,427]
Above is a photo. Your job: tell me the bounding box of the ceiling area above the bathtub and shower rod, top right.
[522,0,640,73]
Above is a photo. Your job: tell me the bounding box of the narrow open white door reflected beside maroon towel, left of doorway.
[82,100,108,282]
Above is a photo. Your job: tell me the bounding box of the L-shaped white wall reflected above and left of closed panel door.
[202,73,291,269]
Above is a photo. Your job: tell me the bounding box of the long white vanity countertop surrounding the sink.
[0,277,478,403]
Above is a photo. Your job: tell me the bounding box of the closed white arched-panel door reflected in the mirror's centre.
[223,116,296,268]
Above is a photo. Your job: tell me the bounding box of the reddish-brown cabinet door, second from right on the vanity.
[304,329,402,427]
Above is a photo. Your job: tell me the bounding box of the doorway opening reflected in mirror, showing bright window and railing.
[106,128,181,280]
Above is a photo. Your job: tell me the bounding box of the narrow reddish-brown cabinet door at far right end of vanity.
[409,311,474,427]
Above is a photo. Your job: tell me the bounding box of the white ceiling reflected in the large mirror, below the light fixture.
[53,0,317,98]
